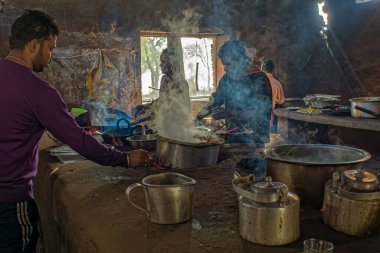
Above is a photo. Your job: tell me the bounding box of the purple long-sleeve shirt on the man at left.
[0,60,127,202]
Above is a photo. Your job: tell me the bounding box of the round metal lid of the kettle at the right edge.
[342,169,379,191]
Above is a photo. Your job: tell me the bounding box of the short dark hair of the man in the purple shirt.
[9,10,59,50]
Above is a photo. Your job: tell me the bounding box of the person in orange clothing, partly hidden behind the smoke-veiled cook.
[261,60,285,133]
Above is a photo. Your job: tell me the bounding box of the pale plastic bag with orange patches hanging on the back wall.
[86,51,119,102]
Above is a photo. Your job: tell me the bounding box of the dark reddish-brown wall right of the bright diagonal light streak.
[328,0,380,96]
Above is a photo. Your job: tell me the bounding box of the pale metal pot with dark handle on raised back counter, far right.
[350,97,380,119]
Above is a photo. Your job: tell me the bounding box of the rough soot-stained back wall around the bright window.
[0,0,379,107]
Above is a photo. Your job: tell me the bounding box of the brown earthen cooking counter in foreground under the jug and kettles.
[35,135,380,253]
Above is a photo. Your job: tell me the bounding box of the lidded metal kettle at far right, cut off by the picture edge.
[322,170,380,236]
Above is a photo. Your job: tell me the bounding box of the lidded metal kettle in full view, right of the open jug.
[232,177,300,246]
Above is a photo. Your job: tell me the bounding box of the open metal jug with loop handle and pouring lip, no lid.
[125,173,196,224]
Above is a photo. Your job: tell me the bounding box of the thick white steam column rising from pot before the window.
[154,9,217,143]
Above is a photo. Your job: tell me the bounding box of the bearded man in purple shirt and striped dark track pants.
[0,10,152,253]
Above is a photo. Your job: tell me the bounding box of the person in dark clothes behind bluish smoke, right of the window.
[197,40,272,147]
